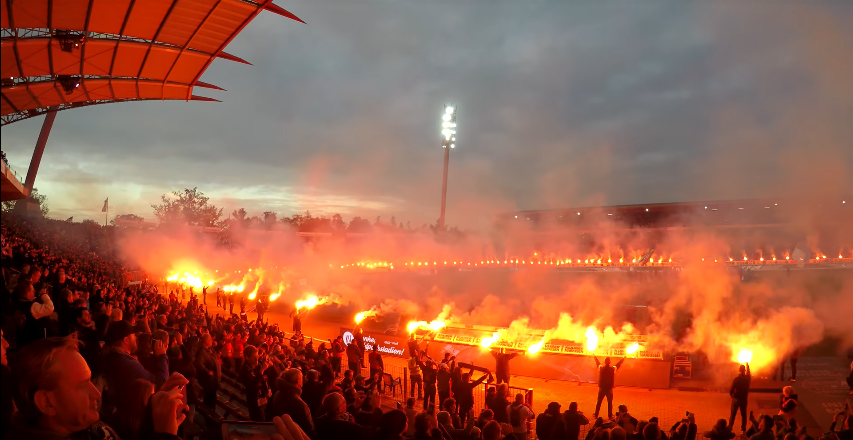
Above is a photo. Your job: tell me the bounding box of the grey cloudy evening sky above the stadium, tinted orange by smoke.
[2,0,853,227]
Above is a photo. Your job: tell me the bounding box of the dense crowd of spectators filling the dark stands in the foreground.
[0,215,851,440]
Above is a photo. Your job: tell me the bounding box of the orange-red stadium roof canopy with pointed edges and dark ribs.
[0,0,302,125]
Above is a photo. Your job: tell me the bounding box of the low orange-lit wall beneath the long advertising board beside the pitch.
[427,341,671,388]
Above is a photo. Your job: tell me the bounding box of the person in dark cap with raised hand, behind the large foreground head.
[103,321,169,406]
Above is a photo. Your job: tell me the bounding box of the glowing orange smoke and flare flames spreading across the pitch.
[115,203,853,378]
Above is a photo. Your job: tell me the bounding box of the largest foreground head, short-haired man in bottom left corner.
[11,338,101,437]
